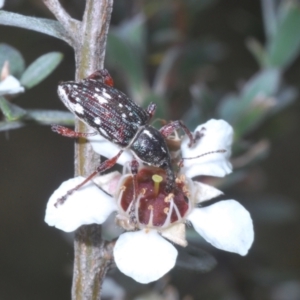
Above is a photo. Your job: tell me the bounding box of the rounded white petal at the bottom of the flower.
[114,230,177,283]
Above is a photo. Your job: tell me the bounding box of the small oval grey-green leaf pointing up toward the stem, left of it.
[20,52,63,89]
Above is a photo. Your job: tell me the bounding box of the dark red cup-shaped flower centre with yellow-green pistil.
[119,168,191,227]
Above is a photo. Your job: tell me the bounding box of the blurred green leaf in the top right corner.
[268,3,300,68]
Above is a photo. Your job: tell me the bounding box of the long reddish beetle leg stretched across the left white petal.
[54,150,123,207]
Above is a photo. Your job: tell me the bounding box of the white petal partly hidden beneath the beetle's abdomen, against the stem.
[88,134,133,165]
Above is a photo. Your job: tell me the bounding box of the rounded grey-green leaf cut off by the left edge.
[0,43,25,78]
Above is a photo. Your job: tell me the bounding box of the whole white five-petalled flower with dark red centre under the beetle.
[45,120,254,283]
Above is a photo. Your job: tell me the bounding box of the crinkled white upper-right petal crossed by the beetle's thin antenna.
[181,119,233,177]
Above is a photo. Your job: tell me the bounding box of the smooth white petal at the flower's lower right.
[188,200,254,255]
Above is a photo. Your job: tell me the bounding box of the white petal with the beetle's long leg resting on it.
[45,176,117,232]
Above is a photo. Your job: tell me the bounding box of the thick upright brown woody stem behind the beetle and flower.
[72,0,113,300]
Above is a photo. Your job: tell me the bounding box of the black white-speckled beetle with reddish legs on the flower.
[52,69,200,210]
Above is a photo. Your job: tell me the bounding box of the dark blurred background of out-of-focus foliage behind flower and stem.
[0,0,300,300]
